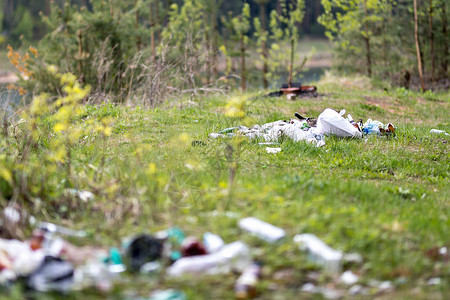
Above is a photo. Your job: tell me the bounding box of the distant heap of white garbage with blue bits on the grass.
[209,108,395,147]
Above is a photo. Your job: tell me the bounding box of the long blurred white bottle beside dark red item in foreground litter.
[167,241,250,276]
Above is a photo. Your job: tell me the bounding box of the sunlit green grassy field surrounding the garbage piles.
[0,76,450,299]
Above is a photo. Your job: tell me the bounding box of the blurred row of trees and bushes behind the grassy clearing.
[0,0,449,93]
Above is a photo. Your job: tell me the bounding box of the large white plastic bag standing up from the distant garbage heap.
[316,108,362,138]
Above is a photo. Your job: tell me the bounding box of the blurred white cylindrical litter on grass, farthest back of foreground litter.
[239,217,286,243]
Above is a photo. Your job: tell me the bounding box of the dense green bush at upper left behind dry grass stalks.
[20,0,146,97]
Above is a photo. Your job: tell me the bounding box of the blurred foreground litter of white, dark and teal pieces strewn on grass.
[0,207,414,299]
